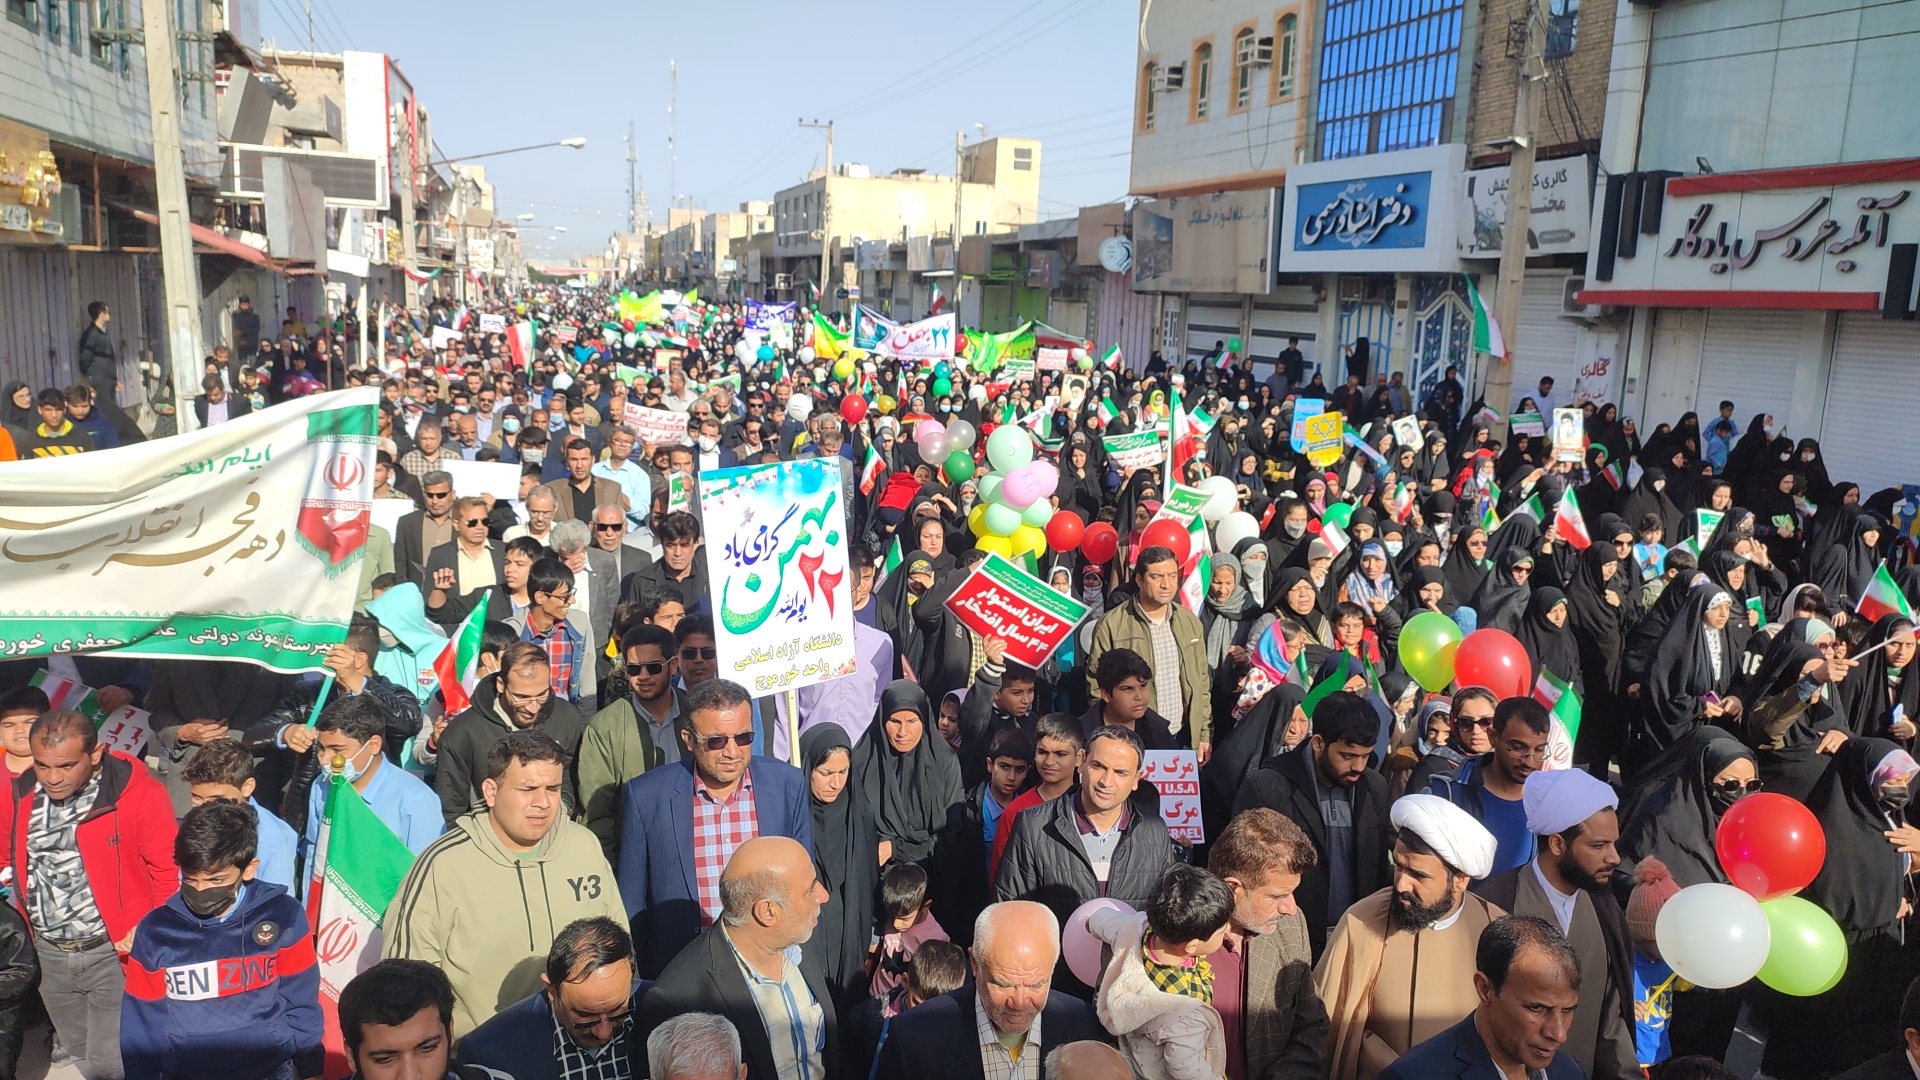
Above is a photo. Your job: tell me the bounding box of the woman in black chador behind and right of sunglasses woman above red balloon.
[1740,619,1853,801]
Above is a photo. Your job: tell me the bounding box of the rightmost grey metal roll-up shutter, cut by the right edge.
[1812,311,1920,502]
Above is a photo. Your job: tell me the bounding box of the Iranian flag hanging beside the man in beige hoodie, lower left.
[307,768,416,1080]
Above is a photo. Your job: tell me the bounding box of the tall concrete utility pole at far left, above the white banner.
[140,4,202,434]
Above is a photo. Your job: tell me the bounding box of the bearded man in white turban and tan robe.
[1313,796,1503,1080]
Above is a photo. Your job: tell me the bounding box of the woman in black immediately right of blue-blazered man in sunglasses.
[801,724,879,1007]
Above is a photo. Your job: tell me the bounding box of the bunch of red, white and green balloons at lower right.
[1653,792,1847,997]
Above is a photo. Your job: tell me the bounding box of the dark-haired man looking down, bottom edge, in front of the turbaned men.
[1379,915,1586,1080]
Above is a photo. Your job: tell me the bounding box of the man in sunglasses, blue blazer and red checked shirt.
[618,678,814,978]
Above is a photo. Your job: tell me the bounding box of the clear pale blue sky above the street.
[259,0,1139,258]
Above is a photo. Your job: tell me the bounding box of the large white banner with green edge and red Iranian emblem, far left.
[0,386,380,671]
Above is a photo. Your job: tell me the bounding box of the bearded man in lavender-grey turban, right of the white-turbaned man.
[1476,769,1640,1080]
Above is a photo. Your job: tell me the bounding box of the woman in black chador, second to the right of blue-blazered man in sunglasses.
[854,678,964,863]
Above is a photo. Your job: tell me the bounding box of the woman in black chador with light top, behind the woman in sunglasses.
[1626,582,1740,767]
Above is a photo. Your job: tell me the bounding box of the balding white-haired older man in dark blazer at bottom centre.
[879,899,1113,1080]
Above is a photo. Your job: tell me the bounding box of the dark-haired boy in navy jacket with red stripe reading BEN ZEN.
[121,799,323,1080]
